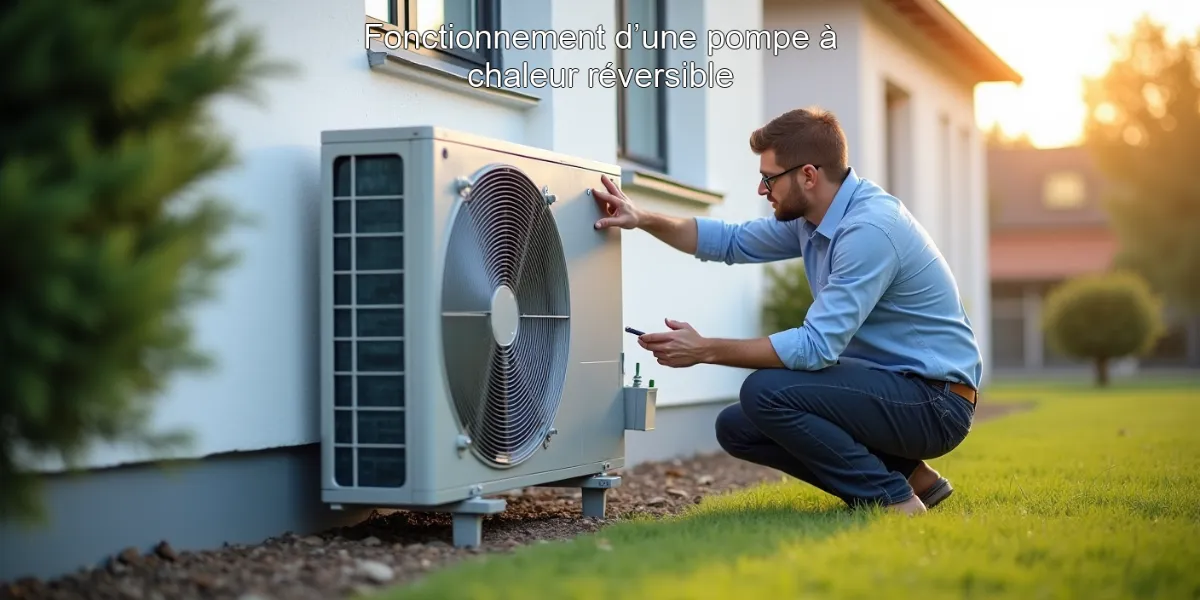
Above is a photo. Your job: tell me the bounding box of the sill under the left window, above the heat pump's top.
[367,41,541,110]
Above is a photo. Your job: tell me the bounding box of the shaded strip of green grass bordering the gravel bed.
[376,484,882,599]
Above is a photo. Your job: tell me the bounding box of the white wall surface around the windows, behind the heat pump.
[30,0,761,470]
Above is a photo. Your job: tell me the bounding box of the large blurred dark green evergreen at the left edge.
[0,0,284,518]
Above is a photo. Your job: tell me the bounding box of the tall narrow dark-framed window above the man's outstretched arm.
[617,0,667,173]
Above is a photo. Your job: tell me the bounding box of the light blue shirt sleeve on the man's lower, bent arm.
[768,223,900,371]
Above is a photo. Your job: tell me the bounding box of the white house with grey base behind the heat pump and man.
[0,0,1016,578]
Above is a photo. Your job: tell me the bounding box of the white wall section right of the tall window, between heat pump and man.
[622,0,766,406]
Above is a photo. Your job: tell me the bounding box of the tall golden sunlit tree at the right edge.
[1085,17,1200,312]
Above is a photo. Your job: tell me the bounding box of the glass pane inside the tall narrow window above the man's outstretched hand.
[622,0,661,160]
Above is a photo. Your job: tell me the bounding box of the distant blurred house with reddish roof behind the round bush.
[988,145,1200,374]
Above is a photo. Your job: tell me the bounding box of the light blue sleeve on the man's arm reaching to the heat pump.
[696,217,803,264]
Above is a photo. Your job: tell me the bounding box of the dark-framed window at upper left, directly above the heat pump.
[365,0,503,68]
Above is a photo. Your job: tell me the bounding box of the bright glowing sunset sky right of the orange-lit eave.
[942,0,1200,148]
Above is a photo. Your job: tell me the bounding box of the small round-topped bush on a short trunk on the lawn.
[1043,271,1164,386]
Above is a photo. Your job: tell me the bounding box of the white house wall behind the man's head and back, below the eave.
[763,0,991,380]
